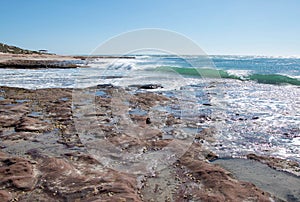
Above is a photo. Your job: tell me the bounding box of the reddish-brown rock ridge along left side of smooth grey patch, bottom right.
[180,147,270,201]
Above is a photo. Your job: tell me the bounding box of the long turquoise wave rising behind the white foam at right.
[156,66,300,86]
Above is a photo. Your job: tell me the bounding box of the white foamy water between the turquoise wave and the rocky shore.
[0,57,300,162]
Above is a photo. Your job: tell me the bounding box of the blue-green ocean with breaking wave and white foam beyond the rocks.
[0,55,300,162]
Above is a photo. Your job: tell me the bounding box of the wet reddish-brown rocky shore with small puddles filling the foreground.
[0,85,295,202]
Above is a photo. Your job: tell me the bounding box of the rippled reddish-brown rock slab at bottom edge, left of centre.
[39,157,139,201]
